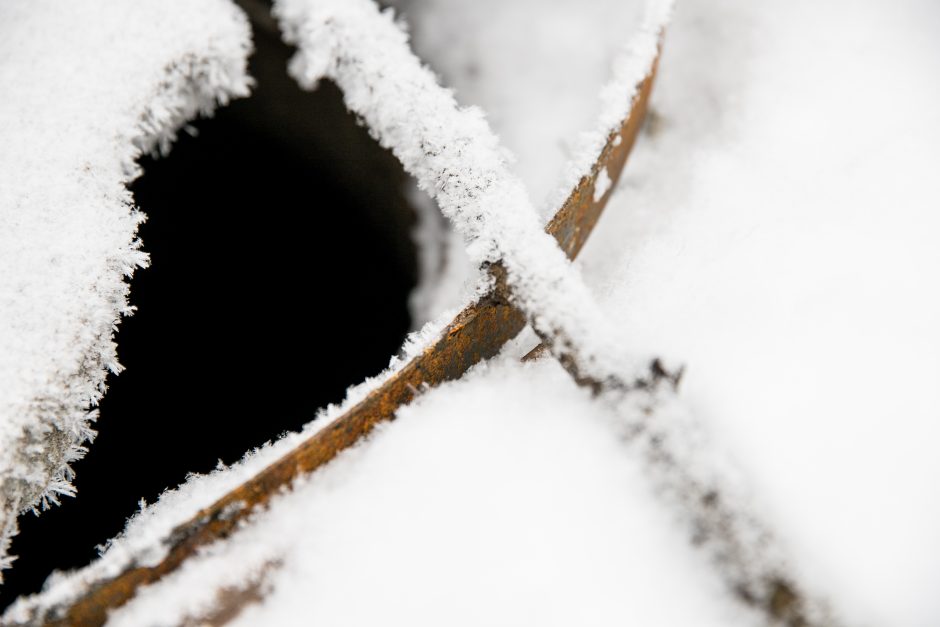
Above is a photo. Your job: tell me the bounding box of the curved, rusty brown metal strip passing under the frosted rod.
[29,54,656,625]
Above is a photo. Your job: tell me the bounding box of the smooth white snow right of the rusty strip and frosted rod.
[581,0,940,627]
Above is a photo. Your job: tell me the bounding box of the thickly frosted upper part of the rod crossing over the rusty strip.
[274,0,655,392]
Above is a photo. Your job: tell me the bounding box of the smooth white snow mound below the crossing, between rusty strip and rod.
[104,361,742,627]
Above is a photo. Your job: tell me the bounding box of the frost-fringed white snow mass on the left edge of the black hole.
[0,0,251,566]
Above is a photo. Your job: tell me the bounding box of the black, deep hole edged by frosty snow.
[0,20,416,607]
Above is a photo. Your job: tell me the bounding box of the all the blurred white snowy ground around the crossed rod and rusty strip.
[3,0,940,627]
